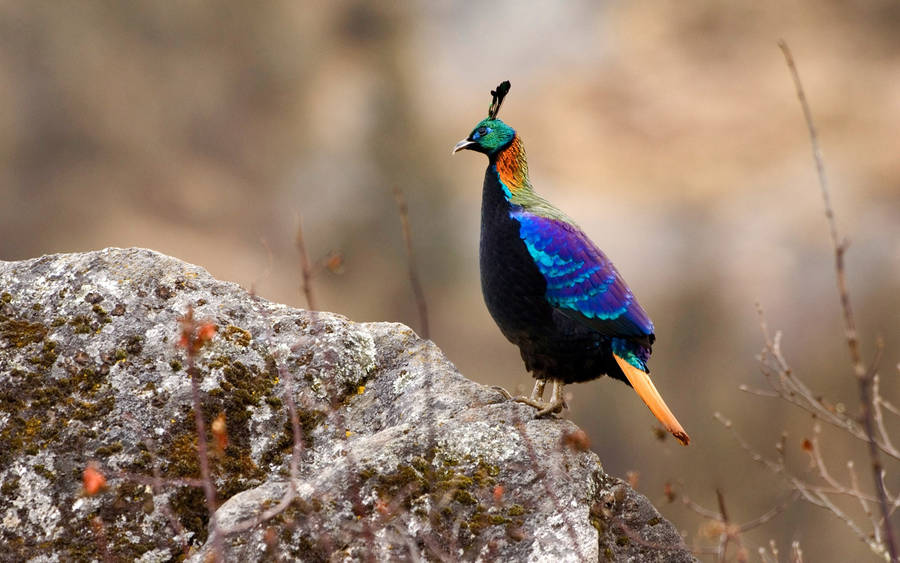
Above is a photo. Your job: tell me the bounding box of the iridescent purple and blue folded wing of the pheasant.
[512,209,653,344]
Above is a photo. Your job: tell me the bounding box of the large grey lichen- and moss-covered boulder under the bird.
[0,249,693,561]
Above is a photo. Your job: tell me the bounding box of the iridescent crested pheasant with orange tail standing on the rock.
[451,80,690,446]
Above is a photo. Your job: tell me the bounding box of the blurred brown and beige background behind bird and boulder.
[0,0,900,561]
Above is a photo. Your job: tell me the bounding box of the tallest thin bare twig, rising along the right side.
[778,40,897,561]
